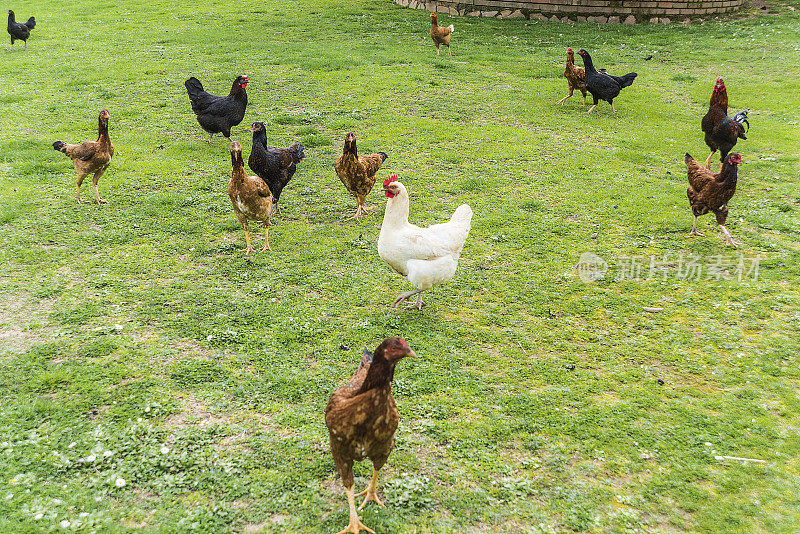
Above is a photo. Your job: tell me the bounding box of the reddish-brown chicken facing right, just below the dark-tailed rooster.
[684,152,742,247]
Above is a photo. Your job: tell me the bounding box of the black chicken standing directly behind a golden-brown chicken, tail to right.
[247,122,306,213]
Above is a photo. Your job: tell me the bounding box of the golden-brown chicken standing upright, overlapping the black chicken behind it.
[228,141,272,254]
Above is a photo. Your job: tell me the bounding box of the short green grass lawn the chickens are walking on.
[0,0,800,533]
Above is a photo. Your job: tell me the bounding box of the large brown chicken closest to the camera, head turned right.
[325,337,416,534]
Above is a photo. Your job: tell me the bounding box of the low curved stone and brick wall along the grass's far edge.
[394,0,744,24]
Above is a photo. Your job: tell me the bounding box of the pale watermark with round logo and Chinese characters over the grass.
[575,252,763,284]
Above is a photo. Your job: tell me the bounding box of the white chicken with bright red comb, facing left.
[378,176,472,310]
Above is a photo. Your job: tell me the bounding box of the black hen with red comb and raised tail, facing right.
[184,74,249,143]
